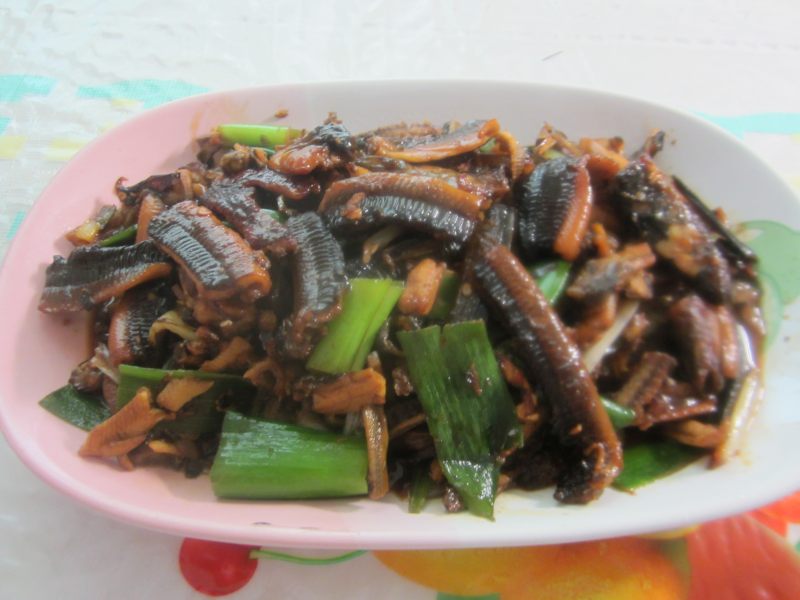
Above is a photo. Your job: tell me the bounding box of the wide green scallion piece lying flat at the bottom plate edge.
[211,411,367,499]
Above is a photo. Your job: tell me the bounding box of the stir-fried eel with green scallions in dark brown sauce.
[39,115,764,518]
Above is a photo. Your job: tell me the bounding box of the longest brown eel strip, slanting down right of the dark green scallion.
[472,232,622,504]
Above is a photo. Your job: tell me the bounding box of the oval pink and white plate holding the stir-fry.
[0,81,800,549]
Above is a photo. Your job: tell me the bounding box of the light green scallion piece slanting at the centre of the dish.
[306,279,403,374]
